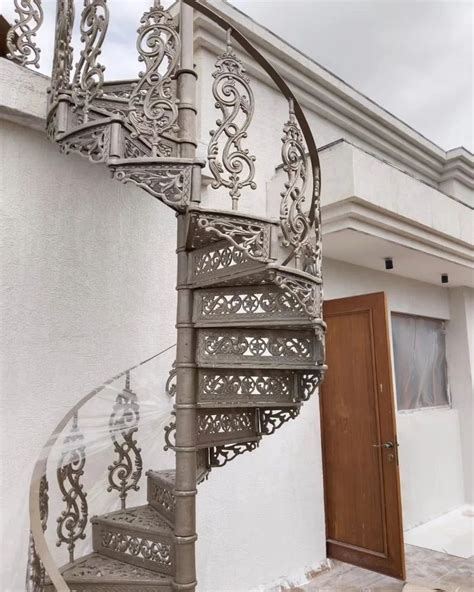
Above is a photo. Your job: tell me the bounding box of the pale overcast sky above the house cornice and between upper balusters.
[2,0,474,152]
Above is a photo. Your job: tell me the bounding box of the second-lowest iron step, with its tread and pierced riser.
[91,505,175,575]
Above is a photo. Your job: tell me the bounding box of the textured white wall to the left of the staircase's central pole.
[0,121,175,592]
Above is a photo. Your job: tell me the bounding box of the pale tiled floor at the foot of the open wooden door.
[293,545,474,592]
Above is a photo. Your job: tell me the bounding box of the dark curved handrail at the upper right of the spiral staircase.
[182,0,321,224]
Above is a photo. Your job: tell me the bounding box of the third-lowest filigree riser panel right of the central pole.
[197,329,314,363]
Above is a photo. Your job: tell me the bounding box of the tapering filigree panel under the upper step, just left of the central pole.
[111,162,192,211]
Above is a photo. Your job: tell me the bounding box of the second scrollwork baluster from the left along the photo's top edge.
[50,0,74,103]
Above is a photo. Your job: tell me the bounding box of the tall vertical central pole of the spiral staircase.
[173,2,200,591]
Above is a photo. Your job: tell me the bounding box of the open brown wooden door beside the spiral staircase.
[320,292,405,579]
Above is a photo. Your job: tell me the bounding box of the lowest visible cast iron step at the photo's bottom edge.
[44,553,173,592]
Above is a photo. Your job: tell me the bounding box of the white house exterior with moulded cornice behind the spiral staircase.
[0,3,474,592]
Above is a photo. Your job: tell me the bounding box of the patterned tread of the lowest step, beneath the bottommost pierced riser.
[52,553,171,584]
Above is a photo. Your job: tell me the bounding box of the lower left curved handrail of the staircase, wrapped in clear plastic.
[29,344,176,592]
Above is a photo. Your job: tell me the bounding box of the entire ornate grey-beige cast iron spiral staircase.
[9,0,325,592]
